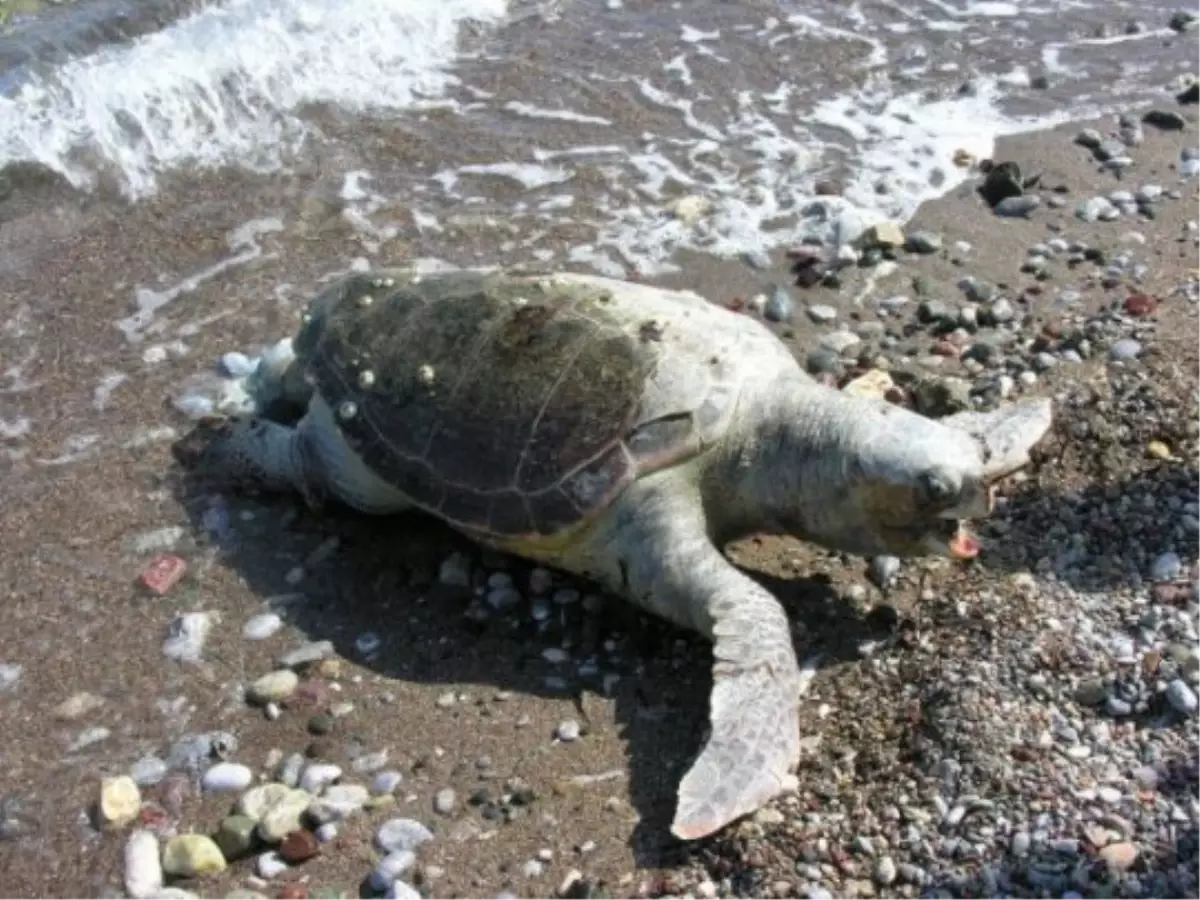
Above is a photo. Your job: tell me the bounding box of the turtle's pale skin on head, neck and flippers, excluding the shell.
[182,271,1050,839]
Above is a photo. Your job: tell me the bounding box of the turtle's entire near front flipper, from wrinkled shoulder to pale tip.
[593,494,802,840]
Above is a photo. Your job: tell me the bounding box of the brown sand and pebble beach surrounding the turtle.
[0,5,1200,900]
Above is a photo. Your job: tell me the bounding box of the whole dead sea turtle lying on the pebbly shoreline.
[177,270,1051,839]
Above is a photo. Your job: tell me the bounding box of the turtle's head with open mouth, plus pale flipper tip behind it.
[826,401,1051,559]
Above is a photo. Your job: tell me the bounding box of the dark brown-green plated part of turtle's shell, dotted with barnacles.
[295,271,715,539]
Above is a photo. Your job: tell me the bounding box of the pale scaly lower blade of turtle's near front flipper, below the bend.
[671,580,800,840]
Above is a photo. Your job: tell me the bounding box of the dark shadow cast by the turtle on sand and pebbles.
[166,444,902,869]
